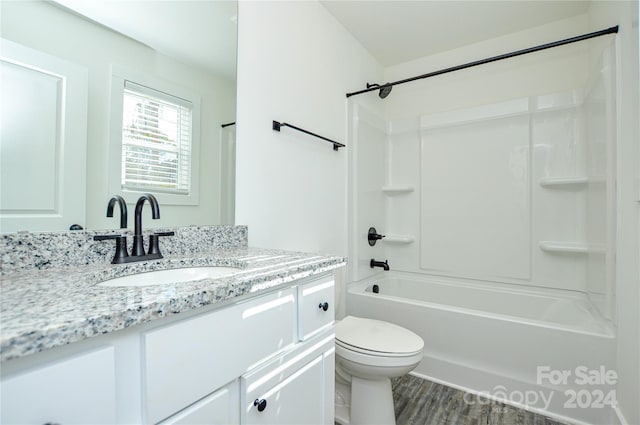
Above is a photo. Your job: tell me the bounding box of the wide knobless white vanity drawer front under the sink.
[143,288,296,423]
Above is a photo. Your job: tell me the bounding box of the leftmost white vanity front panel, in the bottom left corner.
[1,347,116,425]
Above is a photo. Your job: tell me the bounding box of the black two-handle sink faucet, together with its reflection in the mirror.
[93,193,175,264]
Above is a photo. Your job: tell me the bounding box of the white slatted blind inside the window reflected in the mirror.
[122,81,193,194]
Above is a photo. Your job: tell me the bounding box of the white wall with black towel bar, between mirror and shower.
[236,1,381,255]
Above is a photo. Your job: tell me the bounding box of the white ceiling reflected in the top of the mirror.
[49,0,238,80]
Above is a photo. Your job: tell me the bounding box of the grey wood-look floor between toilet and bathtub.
[392,375,563,425]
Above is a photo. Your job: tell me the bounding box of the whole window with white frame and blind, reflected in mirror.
[109,70,200,205]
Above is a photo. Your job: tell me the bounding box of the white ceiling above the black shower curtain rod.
[321,0,590,67]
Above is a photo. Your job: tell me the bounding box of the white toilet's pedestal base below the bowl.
[335,376,396,425]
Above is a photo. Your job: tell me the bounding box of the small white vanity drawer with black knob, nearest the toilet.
[298,275,335,341]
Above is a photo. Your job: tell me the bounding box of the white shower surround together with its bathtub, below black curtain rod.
[346,19,616,423]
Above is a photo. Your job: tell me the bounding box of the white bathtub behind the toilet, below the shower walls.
[346,272,617,424]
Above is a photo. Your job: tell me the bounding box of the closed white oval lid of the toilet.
[336,316,424,354]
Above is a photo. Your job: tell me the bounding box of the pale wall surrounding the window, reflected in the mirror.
[1,1,235,229]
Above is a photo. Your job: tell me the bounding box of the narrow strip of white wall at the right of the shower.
[589,1,640,424]
